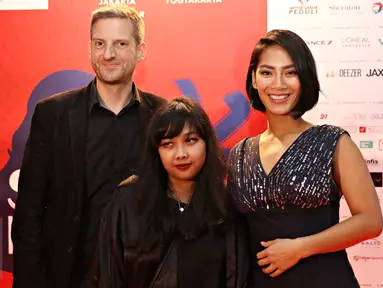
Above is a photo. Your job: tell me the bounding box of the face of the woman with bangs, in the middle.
[158,125,206,182]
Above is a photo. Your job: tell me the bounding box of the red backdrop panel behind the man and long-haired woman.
[0,0,266,287]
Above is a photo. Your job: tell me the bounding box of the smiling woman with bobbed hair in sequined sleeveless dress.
[228,30,382,288]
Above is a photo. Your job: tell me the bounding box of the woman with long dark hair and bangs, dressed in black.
[86,97,248,288]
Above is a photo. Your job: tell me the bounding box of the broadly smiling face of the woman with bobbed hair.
[252,45,301,115]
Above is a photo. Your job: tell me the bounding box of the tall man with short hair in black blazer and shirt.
[12,6,165,288]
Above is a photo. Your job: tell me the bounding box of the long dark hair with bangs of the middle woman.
[136,97,227,247]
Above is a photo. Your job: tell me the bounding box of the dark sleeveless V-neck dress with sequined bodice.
[228,125,359,288]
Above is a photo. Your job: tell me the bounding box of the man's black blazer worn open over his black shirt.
[12,82,166,288]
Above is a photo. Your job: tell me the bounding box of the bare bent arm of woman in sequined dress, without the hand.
[302,135,383,257]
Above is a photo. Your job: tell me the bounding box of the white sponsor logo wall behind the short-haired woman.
[267,0,383,287]
